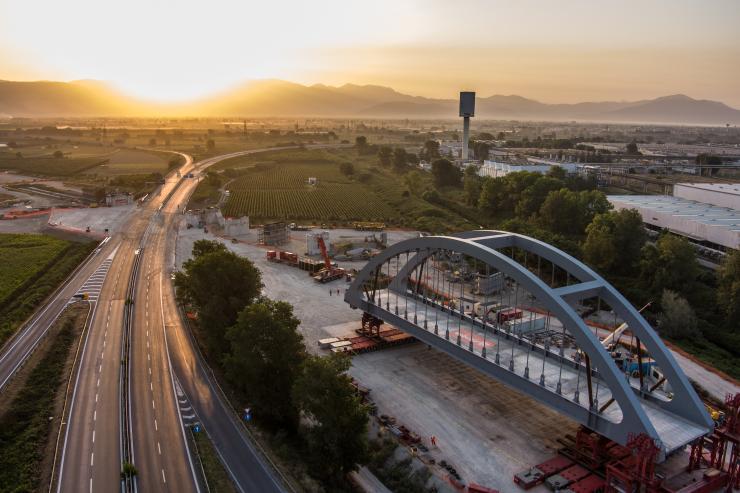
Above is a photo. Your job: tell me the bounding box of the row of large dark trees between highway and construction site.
[175,240,368,485]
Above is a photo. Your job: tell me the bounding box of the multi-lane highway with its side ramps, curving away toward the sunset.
[0,148,298,492]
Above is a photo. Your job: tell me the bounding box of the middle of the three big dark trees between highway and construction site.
[223,299,306,429]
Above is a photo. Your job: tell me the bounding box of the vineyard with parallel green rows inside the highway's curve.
[224,163,397,221]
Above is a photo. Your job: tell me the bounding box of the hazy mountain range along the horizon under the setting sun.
[0,80,740,125]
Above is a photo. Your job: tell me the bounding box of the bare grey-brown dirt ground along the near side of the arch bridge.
[350,343,577,492]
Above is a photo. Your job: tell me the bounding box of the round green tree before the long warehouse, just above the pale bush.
[640,233,699,300]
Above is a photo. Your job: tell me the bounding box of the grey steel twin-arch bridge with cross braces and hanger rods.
[345,230,712,454]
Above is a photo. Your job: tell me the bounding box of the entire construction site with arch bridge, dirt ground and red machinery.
[176,215,740,493]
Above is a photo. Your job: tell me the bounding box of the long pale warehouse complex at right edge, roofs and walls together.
[608,183,740,251]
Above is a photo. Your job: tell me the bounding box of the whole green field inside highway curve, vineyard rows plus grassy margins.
[211,148,473,232]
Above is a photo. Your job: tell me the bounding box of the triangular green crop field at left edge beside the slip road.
[0,234,94,345]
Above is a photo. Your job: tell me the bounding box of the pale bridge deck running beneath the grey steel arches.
[372,290,706,453]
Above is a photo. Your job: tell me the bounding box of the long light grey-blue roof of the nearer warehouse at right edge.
[608,195,740,231]
